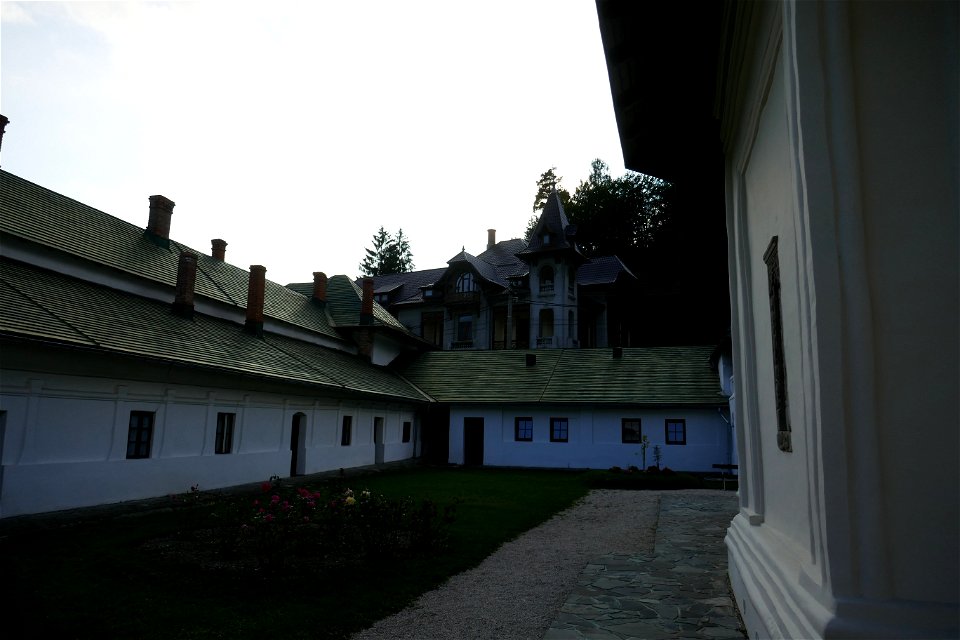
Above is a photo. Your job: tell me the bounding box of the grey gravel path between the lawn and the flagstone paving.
[354,489,660,640]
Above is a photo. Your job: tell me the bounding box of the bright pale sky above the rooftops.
[0,0,623,284]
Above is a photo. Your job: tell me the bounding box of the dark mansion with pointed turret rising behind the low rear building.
[287,191,640,351]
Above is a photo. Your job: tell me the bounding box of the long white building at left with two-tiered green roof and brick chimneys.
[0,162,429,517]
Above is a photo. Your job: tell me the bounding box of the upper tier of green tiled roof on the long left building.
[0,171,340,339]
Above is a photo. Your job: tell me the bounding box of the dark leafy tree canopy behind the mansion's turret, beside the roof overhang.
[527,159,672,260]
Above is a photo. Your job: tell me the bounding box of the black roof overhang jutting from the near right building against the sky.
[597,0,727,183]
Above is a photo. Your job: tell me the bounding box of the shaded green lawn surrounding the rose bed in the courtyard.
[0,468,589,638]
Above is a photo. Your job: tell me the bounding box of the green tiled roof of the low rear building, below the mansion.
[403,346,726,406]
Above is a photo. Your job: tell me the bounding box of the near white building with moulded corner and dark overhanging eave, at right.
[597,0,960,638]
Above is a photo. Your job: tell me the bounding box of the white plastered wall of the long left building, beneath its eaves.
[0,370,416,517]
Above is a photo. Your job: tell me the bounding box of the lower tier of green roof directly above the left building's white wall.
[0,258,425,401]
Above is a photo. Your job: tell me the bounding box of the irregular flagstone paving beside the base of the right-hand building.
[543,492,746,640]
